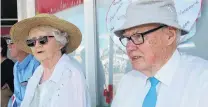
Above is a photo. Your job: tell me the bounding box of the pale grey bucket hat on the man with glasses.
[114,0,188,37]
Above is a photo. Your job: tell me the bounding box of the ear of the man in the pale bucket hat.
[163,27,177,45]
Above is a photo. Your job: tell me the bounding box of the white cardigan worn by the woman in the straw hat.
[21,54,91,107]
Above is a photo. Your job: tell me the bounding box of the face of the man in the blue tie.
[124,24,175,71]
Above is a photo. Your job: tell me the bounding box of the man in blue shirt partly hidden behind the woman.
[6,38,40,107]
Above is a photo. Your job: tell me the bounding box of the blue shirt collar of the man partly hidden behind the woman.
[17,54,33,69]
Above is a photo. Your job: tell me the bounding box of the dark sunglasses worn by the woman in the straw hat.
[26,36,54,47]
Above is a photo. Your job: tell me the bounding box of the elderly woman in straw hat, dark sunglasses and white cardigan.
[10,14,90,107]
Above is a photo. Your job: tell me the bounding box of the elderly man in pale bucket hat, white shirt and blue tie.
[111,0,208,107]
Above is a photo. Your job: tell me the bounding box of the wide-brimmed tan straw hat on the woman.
[10,14,82,53]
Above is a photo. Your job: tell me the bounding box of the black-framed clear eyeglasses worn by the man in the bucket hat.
[119,25,167,47]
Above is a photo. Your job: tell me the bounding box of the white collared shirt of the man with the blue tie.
[111,50,208,107]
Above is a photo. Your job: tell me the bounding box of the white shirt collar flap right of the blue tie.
[155,50,180,86]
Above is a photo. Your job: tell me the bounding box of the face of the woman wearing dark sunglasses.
[27,27,63,61]
